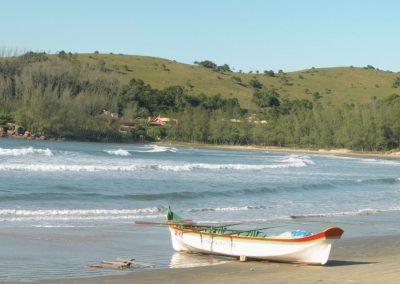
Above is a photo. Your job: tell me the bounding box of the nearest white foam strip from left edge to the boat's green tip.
[0,207,164,221]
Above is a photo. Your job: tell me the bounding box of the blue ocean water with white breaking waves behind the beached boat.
[0,139,400,281]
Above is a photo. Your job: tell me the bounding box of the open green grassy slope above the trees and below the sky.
[69,54,400,109]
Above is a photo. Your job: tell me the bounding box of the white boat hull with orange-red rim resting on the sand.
[169,225,343,265]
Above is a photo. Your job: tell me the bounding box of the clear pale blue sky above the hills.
[0,0,400,72]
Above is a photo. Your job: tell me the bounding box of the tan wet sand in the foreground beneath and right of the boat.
[22,236,400,284]
